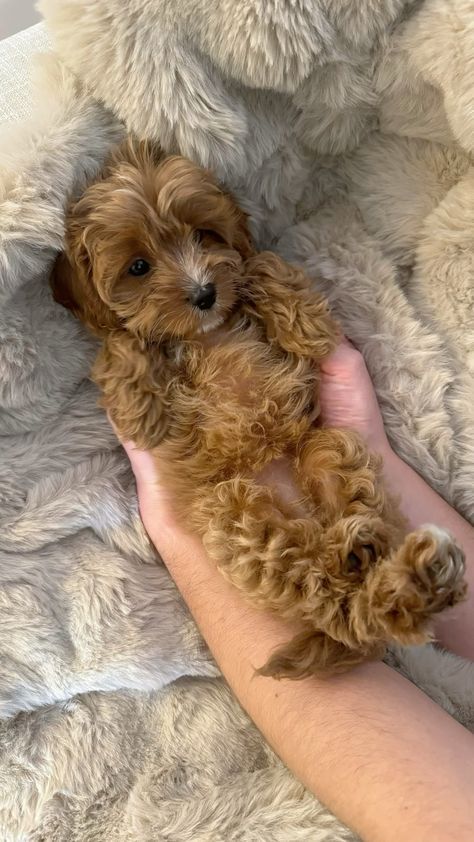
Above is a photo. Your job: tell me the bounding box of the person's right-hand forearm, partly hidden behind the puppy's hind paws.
[384,450,474,660]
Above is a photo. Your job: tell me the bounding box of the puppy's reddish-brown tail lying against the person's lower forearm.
[257,629,384,680]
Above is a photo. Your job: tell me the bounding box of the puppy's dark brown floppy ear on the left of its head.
[50,237,119,336]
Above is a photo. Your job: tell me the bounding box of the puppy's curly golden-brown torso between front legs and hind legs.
[158,335,316,517]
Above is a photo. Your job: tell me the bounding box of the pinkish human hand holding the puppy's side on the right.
[319,339,391,457]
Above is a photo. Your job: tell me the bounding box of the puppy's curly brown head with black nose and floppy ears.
[52,145,253,341]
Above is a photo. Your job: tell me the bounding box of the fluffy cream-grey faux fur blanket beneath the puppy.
[0,0,474,842]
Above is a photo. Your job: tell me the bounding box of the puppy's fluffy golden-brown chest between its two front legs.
[168,328,317,453]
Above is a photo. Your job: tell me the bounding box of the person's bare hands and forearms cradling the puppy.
[118,342,474,842]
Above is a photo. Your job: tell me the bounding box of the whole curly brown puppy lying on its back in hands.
[52,143,465,678]
